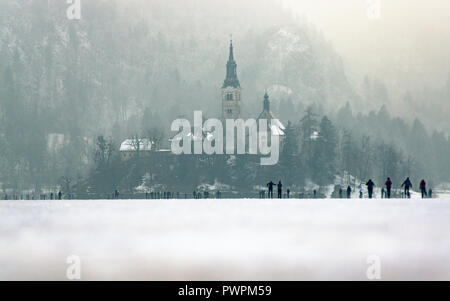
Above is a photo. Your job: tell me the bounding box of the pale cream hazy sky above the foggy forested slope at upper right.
[280,0,450,88]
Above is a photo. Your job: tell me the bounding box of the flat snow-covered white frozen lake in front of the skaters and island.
[0,199,450,280]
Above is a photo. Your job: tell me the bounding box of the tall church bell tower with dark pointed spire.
[222,40,241,120]
